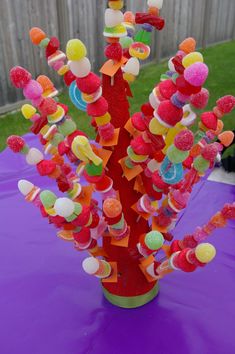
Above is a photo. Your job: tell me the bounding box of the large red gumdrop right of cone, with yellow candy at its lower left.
[157,100,183,127]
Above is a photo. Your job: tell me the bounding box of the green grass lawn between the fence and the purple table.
[0,41,235,151]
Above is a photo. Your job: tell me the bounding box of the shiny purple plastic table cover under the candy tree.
[0,135,235,354]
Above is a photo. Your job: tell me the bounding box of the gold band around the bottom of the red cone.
[103,283,159,309]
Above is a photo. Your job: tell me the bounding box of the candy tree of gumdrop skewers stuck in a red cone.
[7,0,235,308]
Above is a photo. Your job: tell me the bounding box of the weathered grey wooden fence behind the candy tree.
[0,0,235,112]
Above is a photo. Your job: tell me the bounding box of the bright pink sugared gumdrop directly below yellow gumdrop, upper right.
[184,63,209,86]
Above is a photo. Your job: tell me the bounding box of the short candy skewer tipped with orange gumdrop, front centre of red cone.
[103,198,130,240]
